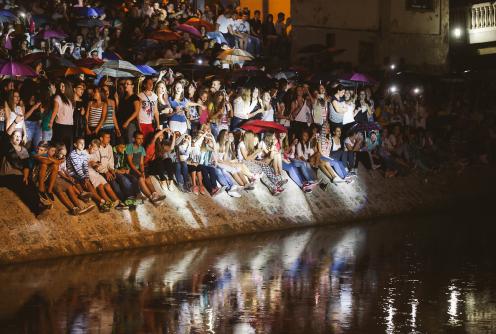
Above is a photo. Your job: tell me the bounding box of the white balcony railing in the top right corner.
[468,1,496,44]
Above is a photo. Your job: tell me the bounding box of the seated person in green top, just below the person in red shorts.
[126,131,165,203]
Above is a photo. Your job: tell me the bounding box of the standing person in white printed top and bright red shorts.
[138,78,160,140]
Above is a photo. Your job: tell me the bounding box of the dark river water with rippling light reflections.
[0,211,496,334]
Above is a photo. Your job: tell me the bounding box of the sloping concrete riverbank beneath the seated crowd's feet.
[0,166,496,263]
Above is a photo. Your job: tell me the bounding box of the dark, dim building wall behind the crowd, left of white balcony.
[291,0,449,70]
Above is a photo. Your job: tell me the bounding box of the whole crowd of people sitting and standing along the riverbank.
[0,0,494,215]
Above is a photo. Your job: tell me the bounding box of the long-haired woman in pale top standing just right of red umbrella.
[290,85,314,140]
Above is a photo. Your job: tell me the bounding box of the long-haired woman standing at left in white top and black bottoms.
[49,81,74,151]
